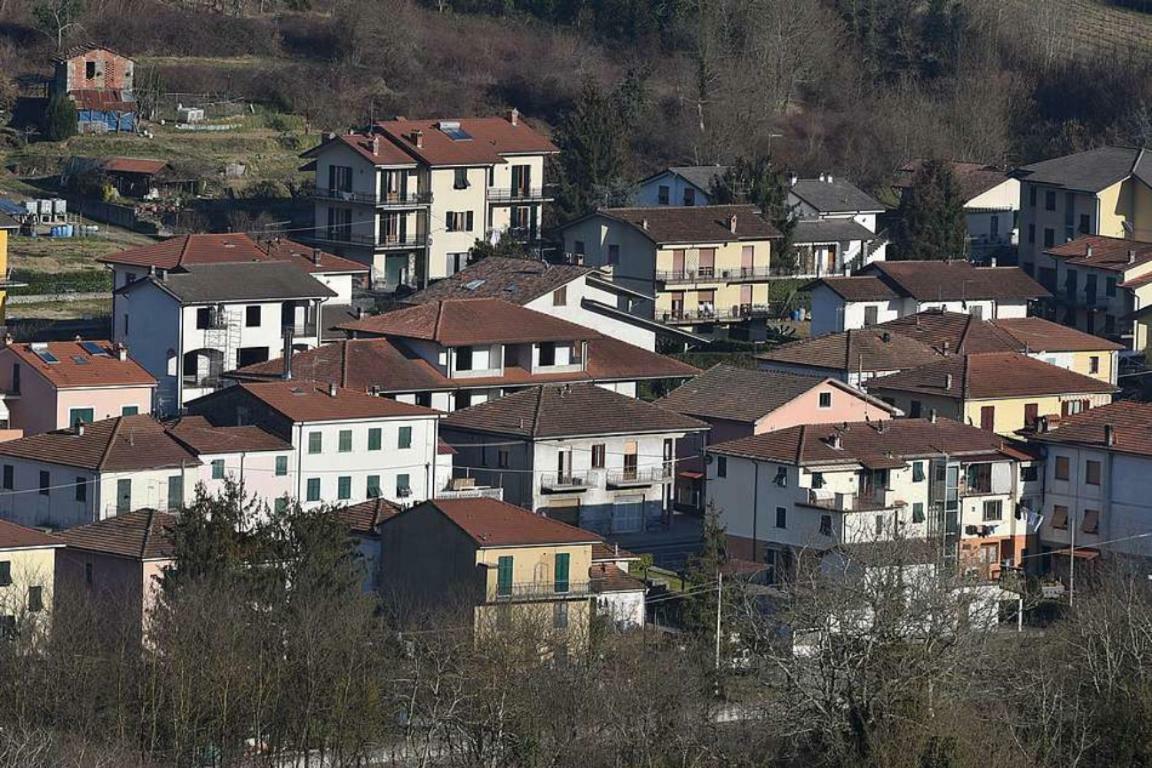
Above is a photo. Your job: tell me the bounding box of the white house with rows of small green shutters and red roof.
[188,380,448,509]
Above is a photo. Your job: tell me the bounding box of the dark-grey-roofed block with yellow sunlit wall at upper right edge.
[1011,146,1152,276]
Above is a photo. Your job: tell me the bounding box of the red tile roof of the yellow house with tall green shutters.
[414,499,601,549]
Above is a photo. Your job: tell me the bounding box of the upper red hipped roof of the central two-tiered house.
[339,298,600,347]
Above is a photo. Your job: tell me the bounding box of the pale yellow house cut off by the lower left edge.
[0,520,65,638]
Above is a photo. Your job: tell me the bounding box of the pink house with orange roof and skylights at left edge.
[0,339,156,436]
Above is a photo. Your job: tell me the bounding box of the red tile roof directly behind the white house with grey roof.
[97,233,367,274]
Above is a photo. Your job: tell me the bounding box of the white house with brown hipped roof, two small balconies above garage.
[444,385,707,535]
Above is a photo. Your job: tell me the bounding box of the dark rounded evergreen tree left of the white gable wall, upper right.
[896,160,968,260]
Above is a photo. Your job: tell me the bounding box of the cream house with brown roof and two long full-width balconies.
[561,205,780,333]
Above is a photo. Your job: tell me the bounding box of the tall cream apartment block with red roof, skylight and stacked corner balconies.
[305,109,558,289]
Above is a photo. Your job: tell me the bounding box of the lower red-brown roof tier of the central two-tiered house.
[228,337,699,394]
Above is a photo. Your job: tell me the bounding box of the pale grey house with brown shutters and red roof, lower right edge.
[1030,401,1152,579]
